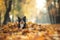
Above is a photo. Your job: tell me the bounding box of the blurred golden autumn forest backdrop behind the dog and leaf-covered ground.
[0,0,60,25]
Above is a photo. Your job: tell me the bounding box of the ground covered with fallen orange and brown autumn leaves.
[0,23,60,40]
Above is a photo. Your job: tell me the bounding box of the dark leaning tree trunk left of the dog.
[3,0,12,24]
